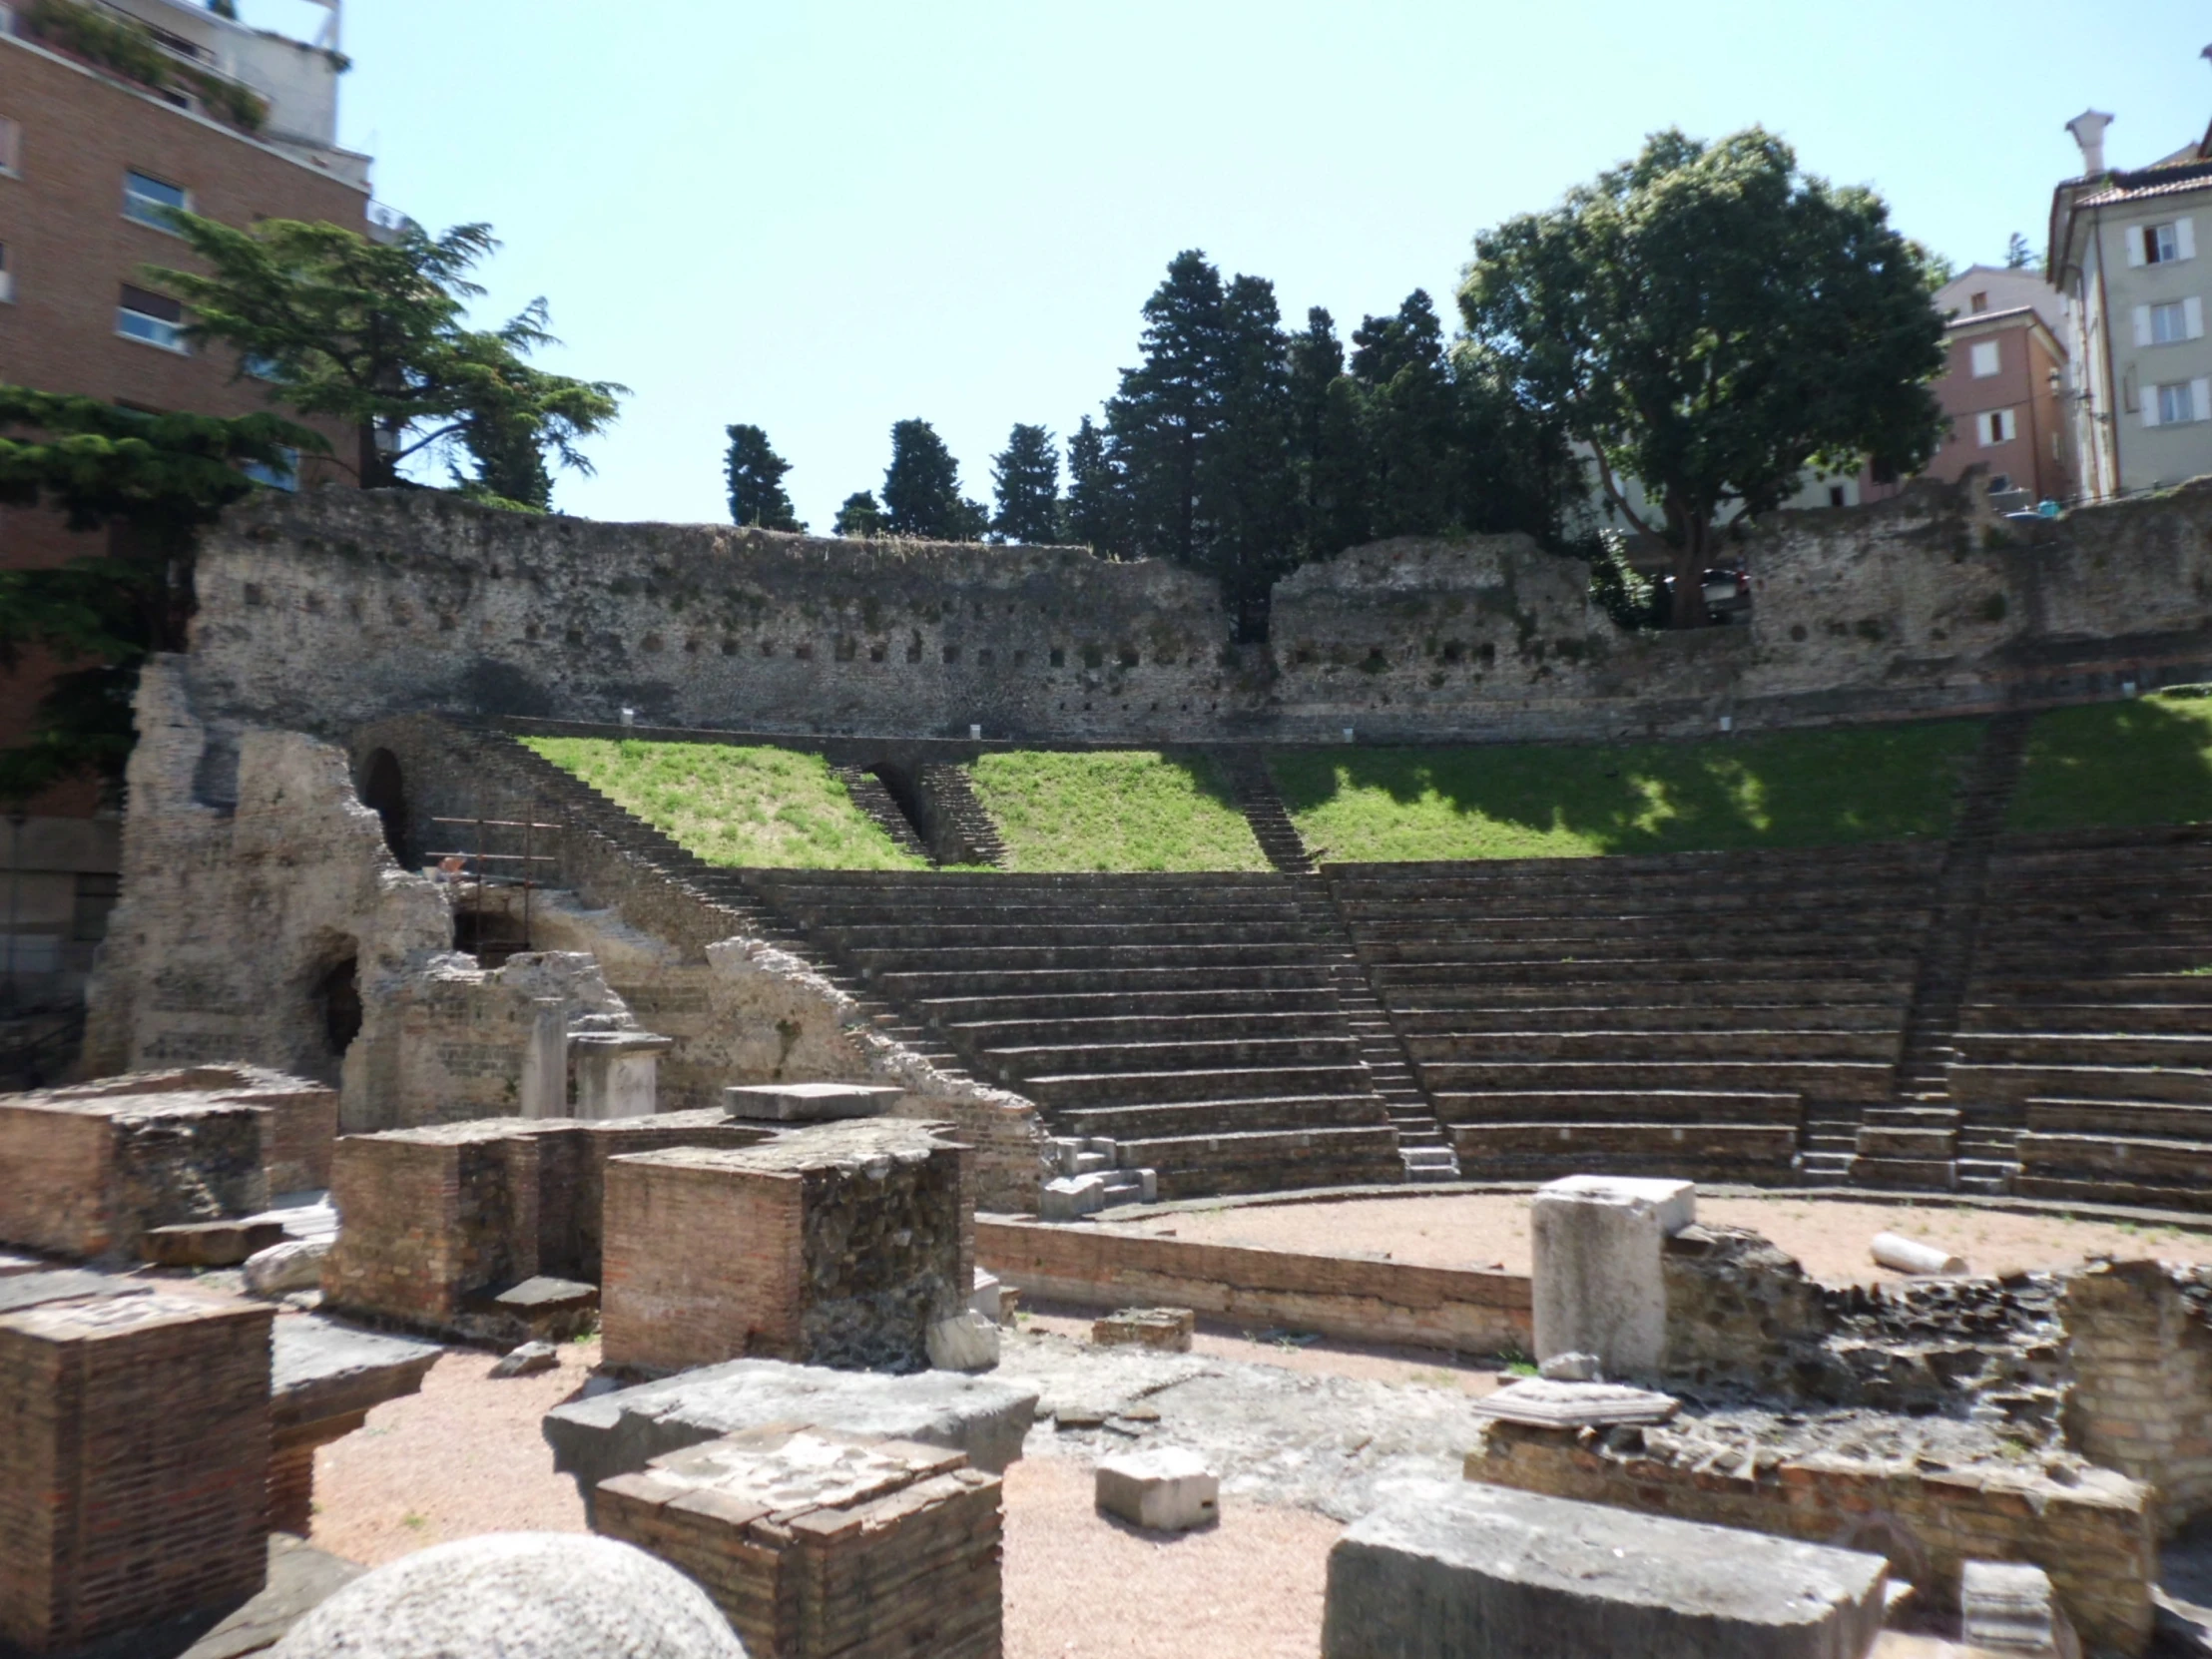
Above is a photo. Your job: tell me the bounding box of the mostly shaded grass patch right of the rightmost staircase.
[2006,695,2212,830]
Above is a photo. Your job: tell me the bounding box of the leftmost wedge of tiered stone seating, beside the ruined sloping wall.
[746,869,1404,1197]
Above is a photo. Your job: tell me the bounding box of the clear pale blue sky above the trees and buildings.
[244,0,2212,531]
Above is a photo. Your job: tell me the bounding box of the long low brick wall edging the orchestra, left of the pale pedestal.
[975,1217,1535,1354]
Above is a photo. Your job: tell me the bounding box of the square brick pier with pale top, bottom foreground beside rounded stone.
[593,1426,1002,1659]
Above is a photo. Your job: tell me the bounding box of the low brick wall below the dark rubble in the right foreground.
[1466,1422,2159,1655]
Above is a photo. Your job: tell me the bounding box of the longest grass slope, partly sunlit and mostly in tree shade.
[1270,721,1982,862]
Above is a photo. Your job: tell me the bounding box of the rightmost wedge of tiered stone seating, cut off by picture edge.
[1951,826,2212,1210]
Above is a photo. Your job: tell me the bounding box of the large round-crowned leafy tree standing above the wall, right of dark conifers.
[1460,129,1944,626]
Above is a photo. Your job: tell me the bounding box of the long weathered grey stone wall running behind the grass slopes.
[177,484,2212,744]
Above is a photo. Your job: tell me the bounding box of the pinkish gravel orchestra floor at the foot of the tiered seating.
[1115,1192,2212,1285]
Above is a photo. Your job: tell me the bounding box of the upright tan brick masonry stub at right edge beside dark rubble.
[2061,1261,2212,1535]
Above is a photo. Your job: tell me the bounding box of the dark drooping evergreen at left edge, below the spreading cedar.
[0,385,327,803]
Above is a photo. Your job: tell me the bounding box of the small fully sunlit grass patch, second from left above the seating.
[971,750,1270,869]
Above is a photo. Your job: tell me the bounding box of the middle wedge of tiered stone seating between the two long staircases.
[1330,842,1942,1181]
